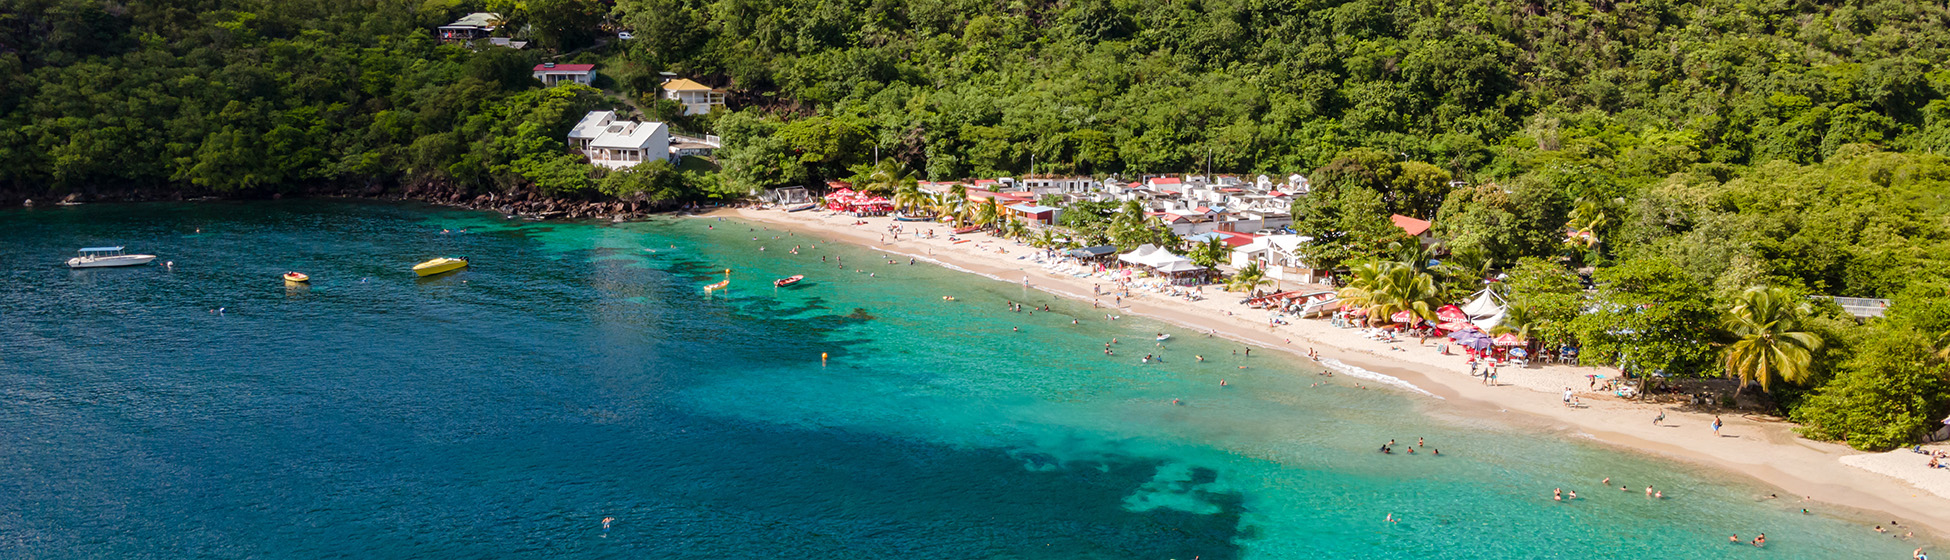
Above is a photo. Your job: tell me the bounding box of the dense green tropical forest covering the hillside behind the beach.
[11,0,1950,449]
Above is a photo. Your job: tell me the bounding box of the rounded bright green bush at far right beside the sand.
[1792,326,1950,451]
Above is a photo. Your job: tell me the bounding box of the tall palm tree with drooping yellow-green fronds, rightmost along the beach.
[1722,287,1821,396]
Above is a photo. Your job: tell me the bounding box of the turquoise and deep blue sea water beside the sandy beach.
[0,201,1915,558]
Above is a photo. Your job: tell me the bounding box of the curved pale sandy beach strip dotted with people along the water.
[708,209,1950,535]
